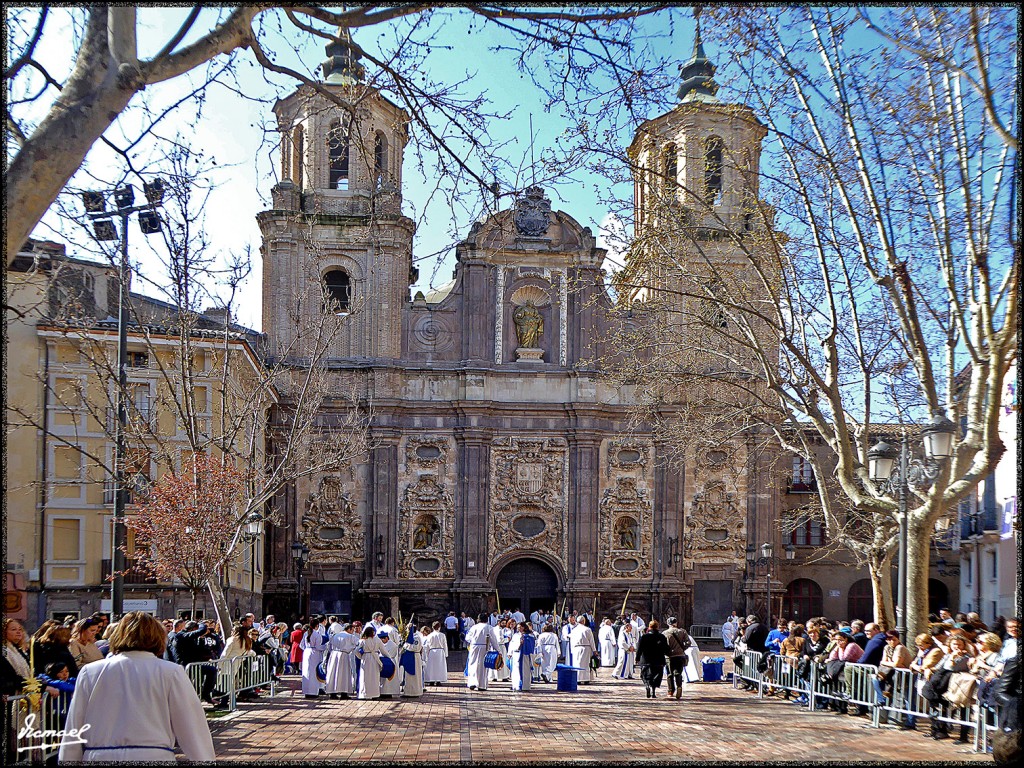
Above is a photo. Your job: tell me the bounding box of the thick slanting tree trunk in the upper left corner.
[4,7,138,264]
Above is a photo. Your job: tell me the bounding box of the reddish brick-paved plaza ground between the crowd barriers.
[203,654,991,765]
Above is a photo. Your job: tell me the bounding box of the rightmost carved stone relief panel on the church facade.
[683,444,746,568]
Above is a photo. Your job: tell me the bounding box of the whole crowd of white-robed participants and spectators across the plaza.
[6,610,1021,760]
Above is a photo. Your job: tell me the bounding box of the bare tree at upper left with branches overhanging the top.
[4,3,671,264]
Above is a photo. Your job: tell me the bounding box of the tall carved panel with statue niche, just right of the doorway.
[597,438,654,579]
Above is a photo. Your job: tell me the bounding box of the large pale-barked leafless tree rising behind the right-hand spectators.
[598,7,1020,632]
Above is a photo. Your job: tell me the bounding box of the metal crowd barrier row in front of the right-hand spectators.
[732,650,998,752]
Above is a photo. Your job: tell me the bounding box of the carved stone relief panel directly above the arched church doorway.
[487,437,568,568]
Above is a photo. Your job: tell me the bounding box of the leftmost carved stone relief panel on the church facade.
[301,475,365,563]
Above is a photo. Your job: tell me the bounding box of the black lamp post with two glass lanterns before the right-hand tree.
[867,412,956,644]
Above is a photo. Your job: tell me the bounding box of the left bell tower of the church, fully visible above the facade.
[257,28,415,359]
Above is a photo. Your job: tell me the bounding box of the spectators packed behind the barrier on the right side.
[722,609,1021,740]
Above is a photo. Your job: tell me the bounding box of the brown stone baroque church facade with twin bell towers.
[259,34,783,624]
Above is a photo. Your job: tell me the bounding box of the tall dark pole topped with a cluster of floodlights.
[82,178,164,620]
